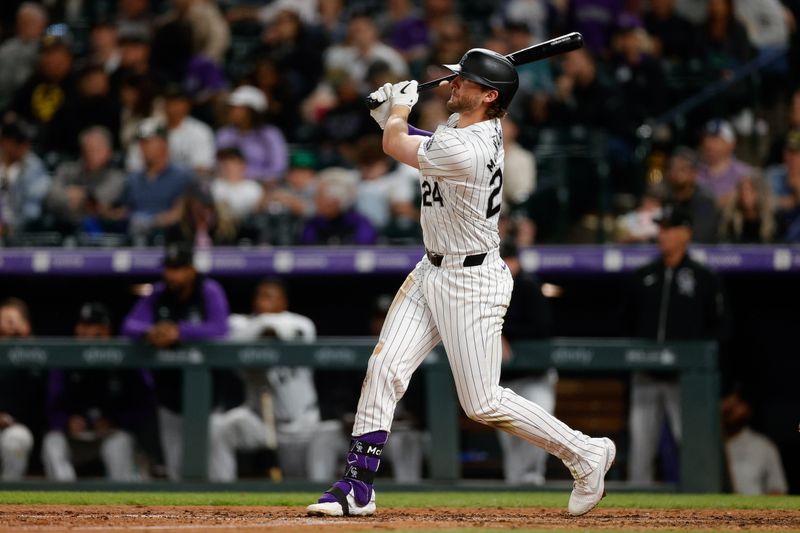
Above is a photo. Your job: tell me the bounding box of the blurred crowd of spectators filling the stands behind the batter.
[0,0,800,246]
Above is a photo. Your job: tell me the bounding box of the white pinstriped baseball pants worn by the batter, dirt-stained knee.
[353,250,605,477]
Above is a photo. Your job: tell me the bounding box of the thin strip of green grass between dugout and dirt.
[0,491,800,510]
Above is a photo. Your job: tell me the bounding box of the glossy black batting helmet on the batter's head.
[443,48,519,109]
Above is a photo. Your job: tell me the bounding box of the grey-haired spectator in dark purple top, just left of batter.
[302,167,377,245]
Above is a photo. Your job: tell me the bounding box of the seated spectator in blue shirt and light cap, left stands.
[117,118,192,242]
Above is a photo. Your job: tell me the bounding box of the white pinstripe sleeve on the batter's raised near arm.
[417,126,475,179]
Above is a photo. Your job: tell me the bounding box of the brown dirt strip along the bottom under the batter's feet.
[0,505,800,533]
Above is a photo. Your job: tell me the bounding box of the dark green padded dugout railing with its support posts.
[0,338,723,492]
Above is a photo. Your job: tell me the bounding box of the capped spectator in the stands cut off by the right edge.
[767,129,800,242]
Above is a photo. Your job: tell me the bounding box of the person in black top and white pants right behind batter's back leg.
[497,240,558,485]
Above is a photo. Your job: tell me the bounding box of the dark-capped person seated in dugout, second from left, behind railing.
[42,302,155,481]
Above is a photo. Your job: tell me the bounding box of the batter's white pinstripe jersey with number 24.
[417,113,504,255]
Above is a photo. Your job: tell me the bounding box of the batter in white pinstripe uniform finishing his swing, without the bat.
[307,48,616,516]
